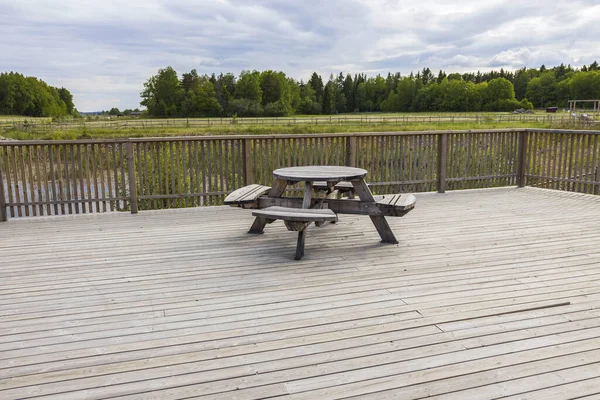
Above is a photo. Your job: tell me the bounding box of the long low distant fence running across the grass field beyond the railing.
[0,114,593,132]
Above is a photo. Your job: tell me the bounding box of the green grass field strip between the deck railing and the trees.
[0,111,589,140]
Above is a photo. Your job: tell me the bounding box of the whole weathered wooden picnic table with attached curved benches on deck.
[225,166,416,260]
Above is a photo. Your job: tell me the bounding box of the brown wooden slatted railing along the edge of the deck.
[0,129,600,221]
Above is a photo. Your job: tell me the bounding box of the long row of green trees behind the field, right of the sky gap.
[140,62,600,117]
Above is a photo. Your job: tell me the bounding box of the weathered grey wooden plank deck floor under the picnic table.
[0,188,600,400]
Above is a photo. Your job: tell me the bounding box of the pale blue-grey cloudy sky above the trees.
[0,0,600,111]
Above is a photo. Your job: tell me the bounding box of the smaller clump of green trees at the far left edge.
[0,72,77,117]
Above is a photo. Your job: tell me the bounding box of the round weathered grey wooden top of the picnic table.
[273,165,367,182]
